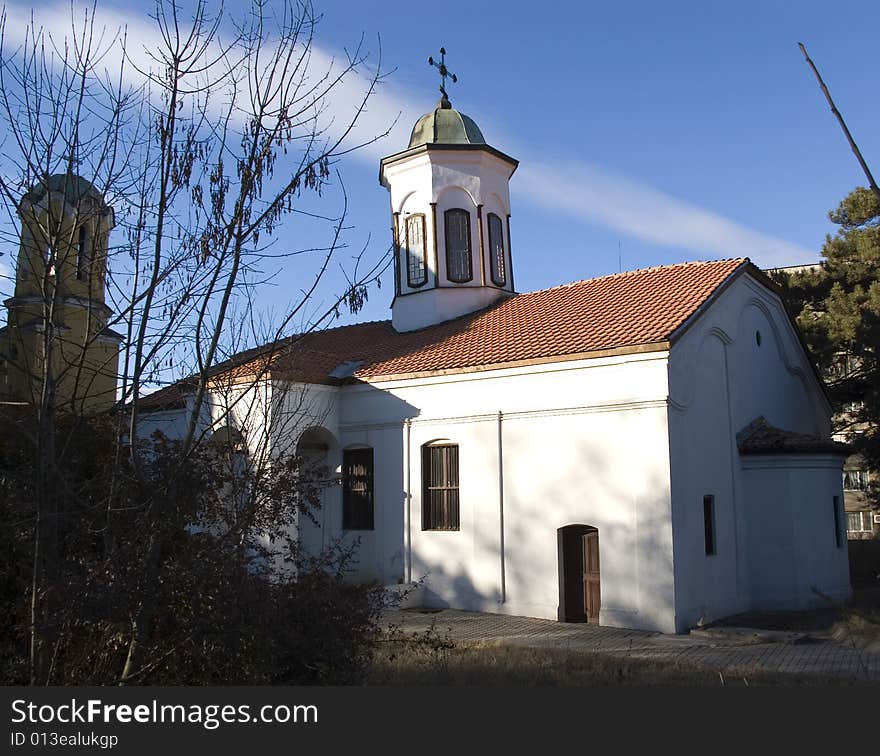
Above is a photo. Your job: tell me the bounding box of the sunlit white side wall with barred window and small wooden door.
[330,352,674,631]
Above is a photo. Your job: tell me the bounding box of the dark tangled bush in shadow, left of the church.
[0,418,384,685]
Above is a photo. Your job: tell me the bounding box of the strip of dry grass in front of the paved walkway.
[367,643,859,687]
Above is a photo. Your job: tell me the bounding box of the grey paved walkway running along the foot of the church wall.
[386,609,880,682]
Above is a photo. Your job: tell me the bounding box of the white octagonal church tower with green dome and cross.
[379,48,518,331]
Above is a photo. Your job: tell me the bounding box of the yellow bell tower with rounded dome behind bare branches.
[0,173,122,414]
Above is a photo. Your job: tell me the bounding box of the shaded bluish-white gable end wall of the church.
[669,274,845,631]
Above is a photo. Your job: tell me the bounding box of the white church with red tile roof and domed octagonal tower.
[141,88,850,633]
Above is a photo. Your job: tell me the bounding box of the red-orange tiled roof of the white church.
[138,258,756,405]
